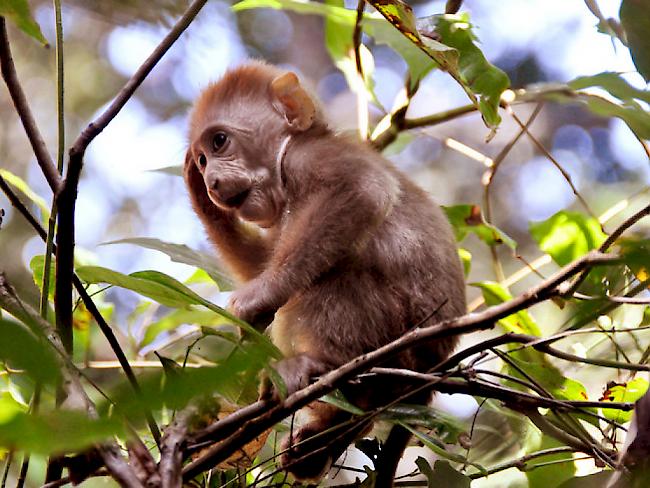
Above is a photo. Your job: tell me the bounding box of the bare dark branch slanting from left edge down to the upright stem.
[0,17,61,195]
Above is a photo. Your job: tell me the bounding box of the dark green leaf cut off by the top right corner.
[619,0,650,82]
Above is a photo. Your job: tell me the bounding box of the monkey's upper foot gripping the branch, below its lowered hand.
[260,354,331,401]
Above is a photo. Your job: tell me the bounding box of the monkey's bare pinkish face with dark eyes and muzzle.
[190,117,286,227]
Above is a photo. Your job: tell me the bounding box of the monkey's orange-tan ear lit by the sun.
[271,72,316,131]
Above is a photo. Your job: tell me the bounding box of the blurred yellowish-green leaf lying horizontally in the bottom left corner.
[0,410,124,455]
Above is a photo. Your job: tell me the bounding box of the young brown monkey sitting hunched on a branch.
[184,61,466,486]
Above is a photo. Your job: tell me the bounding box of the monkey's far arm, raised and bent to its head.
[185,162,270,281]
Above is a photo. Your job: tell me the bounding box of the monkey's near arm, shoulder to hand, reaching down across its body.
[230,168,399,322]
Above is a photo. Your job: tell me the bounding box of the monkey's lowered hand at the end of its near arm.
[228,275,286,330]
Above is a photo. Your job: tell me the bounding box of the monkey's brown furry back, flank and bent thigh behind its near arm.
[272,137,466,376]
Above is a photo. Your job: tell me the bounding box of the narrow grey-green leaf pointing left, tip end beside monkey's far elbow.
[102,237,233,291]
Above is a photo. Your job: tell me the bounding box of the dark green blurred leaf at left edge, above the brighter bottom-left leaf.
[0,318,60,384]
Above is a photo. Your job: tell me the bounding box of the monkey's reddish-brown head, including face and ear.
[185,62,324,227]
